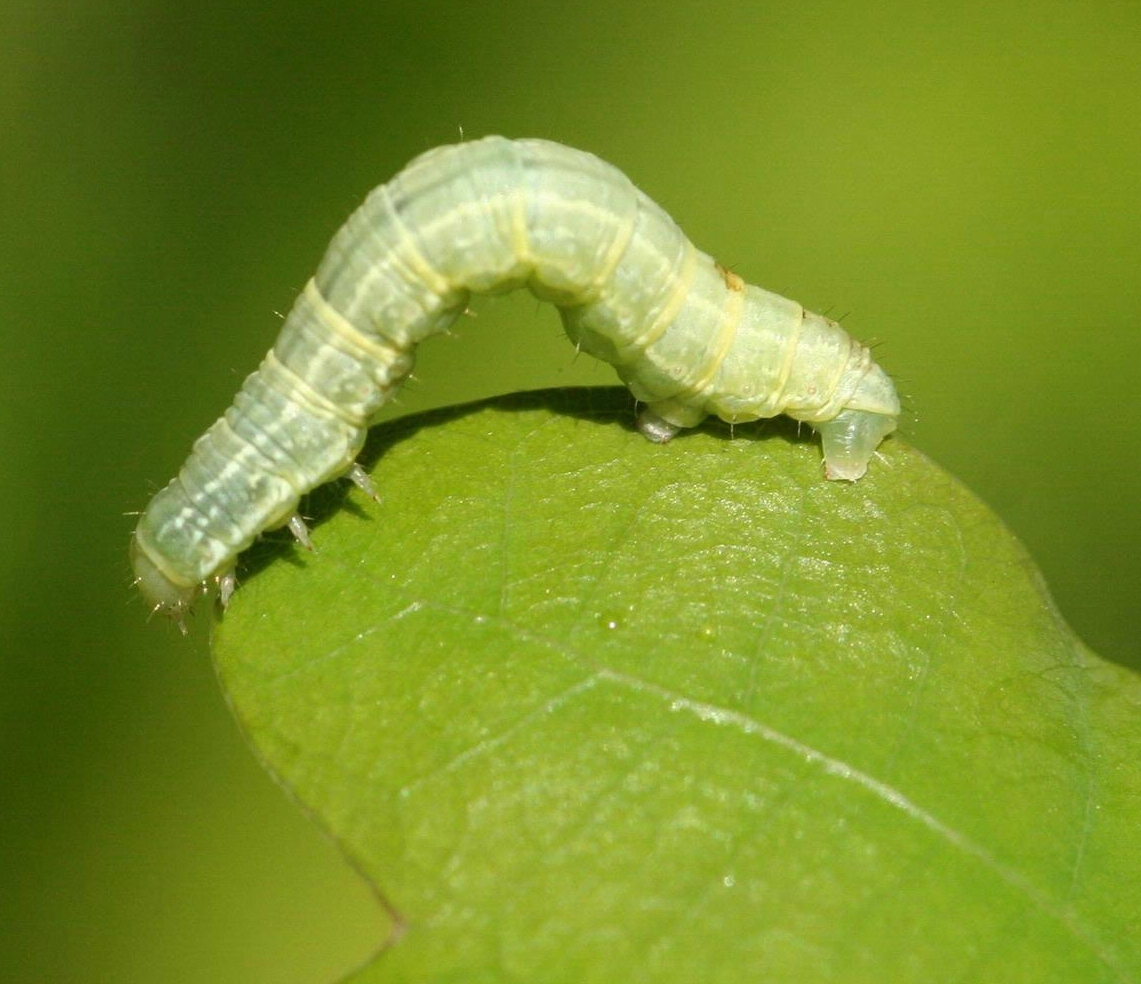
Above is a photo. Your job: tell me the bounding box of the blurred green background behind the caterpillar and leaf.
[0,0,1141,984]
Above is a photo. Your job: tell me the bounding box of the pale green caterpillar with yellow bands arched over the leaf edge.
[131,137,899,621]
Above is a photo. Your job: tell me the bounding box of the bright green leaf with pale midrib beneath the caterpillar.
[216,389,1141,984]
